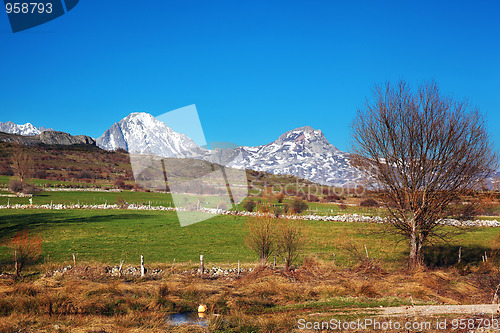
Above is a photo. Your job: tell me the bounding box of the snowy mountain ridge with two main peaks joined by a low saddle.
[97,113,362,186]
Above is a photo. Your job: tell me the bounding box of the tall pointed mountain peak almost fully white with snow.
[96,112,201,157]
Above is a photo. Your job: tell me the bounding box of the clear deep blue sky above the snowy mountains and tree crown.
[0,0,500,150]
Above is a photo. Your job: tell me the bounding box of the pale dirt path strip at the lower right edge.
[378,304,500,316]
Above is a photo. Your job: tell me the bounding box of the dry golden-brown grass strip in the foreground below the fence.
[0,258,500,332]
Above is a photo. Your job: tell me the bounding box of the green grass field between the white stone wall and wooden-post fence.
[0,210,498,267]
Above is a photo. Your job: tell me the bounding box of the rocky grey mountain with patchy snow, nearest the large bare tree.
[229,126,362,187]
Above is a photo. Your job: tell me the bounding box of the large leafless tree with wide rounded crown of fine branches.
[352,81,498,268]
